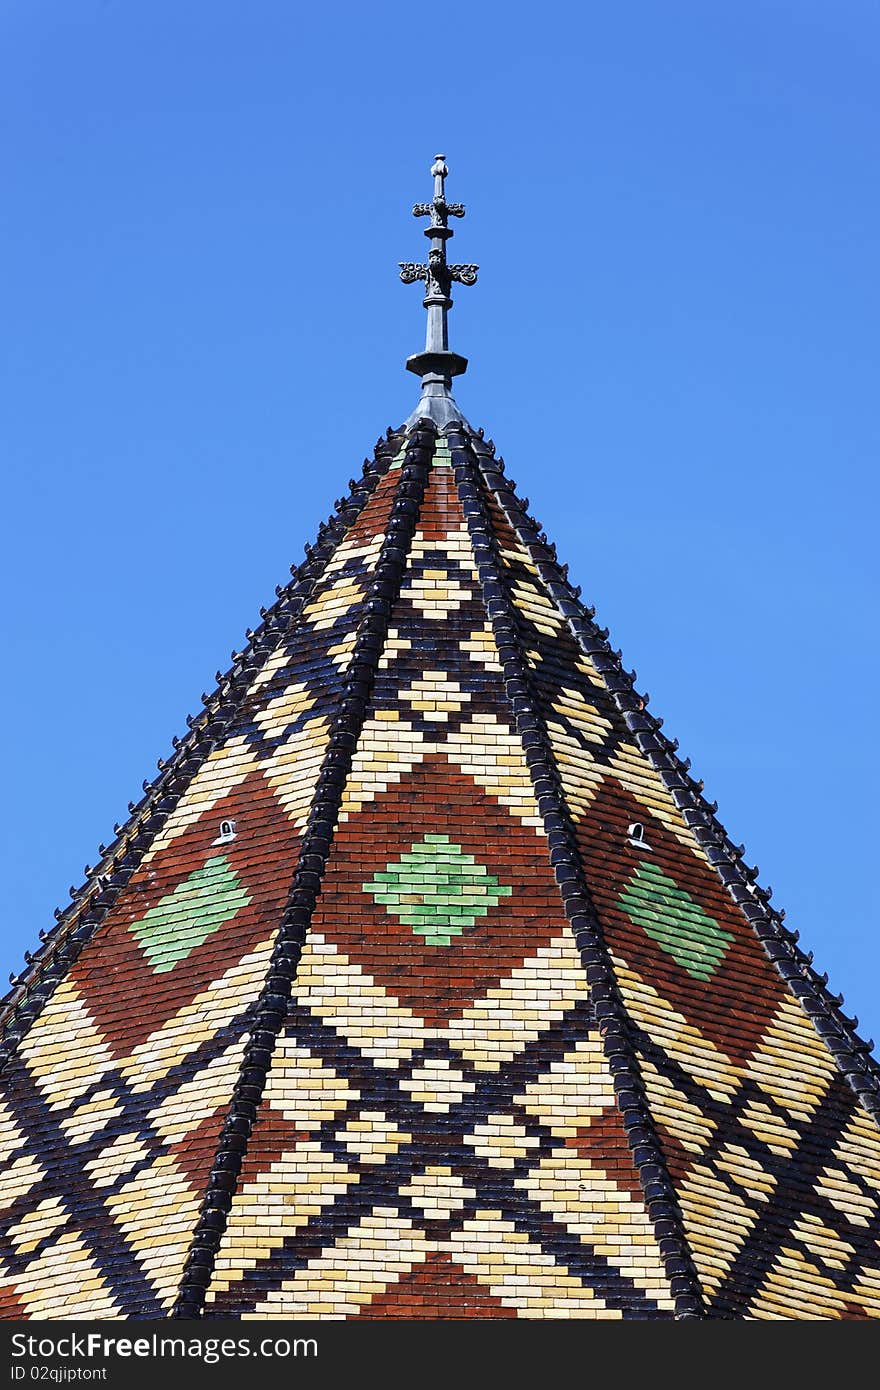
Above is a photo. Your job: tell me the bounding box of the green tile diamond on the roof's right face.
[619,860,733,983]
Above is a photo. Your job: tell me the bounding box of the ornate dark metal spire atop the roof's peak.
[399,154,478,425]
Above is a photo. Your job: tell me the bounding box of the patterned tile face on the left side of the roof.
[0,430,405,1318]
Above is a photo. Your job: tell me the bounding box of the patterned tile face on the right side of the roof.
[472,450,880,1318]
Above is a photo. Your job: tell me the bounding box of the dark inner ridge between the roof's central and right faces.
[448,430,705,1319]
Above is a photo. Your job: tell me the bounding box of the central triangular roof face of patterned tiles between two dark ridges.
[209,450,671,1318]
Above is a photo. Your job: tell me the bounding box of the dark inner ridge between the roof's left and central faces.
[171,424,435,1319]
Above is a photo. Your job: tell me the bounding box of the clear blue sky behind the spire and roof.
[0,0,880,1045]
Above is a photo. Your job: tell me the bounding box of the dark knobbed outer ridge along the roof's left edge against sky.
[0,427,403,1072]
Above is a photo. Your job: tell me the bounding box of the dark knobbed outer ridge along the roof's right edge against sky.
[469,441,880,1122]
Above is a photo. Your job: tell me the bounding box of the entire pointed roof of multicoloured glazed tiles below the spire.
[0,168,880,1319]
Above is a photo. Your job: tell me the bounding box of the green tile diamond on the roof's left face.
[129,855,250,974]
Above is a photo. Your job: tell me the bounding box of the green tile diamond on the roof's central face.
[363,835,512,947]
